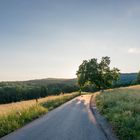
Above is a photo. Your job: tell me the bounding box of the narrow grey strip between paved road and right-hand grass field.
[90,93,119,140]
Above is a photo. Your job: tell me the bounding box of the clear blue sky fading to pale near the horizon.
[0,0,140,81]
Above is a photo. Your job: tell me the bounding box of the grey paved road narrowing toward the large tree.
[1,95,106,140]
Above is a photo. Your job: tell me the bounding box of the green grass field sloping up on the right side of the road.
[96,86,140,140]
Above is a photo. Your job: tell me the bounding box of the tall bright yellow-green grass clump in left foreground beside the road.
[0,105,47,137]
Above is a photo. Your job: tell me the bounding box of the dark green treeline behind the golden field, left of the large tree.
[0,82,79,104]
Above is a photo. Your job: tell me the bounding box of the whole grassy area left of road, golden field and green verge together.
[0,93,79,137]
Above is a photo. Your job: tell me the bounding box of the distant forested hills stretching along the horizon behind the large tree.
[0,73,137,104]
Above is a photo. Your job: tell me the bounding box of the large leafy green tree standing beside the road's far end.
[76,56,120,90]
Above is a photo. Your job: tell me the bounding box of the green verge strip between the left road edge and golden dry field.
[0,93,79,137]
